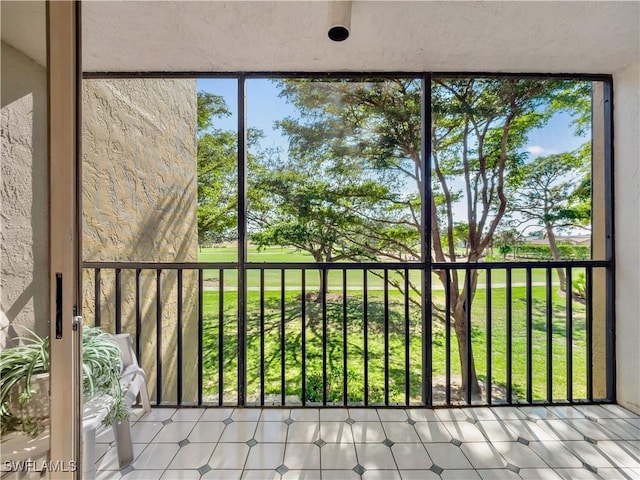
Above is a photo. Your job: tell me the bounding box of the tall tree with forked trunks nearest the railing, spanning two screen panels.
[251,78,580,396]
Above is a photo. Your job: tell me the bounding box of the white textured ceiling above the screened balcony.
[82,0,640,73]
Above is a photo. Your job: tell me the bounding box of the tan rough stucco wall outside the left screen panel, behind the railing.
[82,79,198,401]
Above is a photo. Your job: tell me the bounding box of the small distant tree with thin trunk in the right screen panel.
[510,151,591,291]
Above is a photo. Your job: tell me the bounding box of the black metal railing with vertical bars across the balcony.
[83,260,615,407]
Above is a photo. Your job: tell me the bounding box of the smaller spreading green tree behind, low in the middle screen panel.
[248,109,412,300]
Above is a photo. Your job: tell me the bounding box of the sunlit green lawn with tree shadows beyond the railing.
[199,248,586,403]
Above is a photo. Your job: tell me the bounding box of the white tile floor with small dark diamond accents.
[96,405,640,480]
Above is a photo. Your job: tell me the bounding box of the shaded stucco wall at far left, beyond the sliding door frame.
[0,42,49,348]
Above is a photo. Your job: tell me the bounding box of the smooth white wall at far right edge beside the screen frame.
[614,62,640,414]
